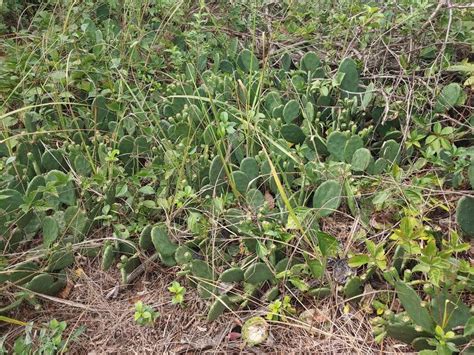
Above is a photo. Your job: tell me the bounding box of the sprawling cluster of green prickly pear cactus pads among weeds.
[0,35,474,355]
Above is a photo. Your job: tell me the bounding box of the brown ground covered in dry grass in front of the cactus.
[0,253,409,354]
